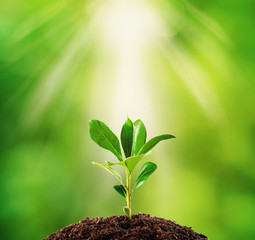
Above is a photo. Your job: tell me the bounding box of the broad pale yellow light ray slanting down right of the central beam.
[161,42,227,123]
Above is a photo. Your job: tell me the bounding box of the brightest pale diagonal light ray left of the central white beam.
[21,23,92,127]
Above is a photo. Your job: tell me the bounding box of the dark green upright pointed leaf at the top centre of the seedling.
[121,117,133,157]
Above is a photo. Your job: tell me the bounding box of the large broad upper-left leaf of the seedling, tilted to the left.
[89,120,123,161]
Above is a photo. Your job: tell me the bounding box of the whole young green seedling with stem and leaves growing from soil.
[89,117,175,219]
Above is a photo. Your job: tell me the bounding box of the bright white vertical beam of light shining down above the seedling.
[89,0,164,124]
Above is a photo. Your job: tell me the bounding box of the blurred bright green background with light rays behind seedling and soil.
[0,0,255,240]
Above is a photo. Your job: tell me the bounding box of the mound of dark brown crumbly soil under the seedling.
[44,213,208,240]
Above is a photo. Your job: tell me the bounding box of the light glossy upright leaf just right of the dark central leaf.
[132,119,147,156]
